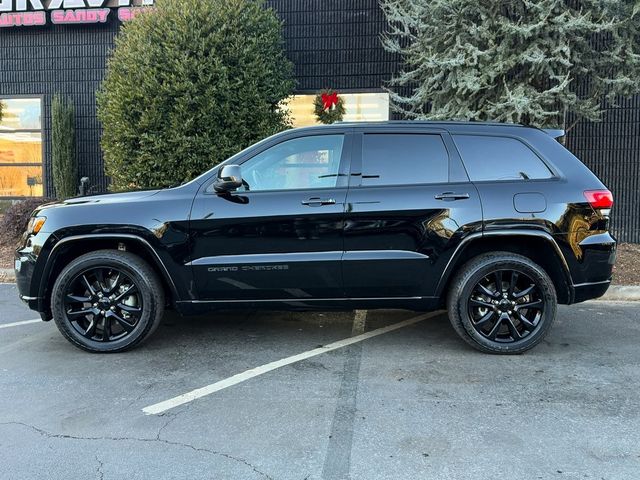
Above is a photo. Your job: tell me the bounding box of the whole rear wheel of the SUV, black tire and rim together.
[447,252,558,355]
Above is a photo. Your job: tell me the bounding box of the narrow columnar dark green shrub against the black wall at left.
[51,95,78,199]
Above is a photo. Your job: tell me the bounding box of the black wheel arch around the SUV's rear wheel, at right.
[436,230,573,304]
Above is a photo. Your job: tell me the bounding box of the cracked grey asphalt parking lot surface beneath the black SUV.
[0,285,640,480]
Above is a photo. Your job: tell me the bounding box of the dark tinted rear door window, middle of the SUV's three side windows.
[362,134,449,185]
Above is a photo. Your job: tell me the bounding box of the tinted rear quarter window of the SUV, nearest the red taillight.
[453,135,553,182]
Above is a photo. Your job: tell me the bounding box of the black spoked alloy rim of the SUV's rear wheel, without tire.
[468,270,545,343]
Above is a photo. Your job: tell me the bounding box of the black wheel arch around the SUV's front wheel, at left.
[38,234,180,316]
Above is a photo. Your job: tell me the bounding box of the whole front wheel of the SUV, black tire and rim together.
[51,250,165,353]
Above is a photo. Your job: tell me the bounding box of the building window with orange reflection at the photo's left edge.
[0,98,44,198]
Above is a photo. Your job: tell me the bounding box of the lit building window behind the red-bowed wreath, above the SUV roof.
[287,93,389,127]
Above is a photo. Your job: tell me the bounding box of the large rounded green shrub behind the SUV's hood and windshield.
[98,0,294,190]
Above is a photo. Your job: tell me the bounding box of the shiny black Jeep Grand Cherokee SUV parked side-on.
[16,122,616,353]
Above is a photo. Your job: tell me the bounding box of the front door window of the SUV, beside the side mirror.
[241,135,344,192]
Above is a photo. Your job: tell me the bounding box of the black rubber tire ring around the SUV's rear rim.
[456,258,557,353]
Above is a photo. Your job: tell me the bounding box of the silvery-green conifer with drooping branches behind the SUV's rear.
[381,0,640,128]
